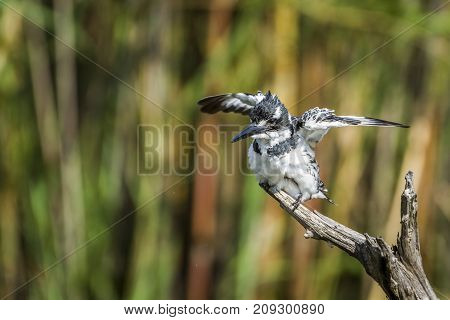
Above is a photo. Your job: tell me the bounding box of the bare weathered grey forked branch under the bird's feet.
[261,171,437,299]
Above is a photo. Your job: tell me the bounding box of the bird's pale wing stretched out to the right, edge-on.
[296,107,409,149]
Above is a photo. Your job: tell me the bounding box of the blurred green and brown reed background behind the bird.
[0,0,450,299]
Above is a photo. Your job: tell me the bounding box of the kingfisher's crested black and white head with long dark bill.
[231,91,292,142]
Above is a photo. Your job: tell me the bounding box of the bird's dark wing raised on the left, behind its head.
[198,91,264,115]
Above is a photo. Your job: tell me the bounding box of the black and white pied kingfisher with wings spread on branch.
[198,91,408,205]
